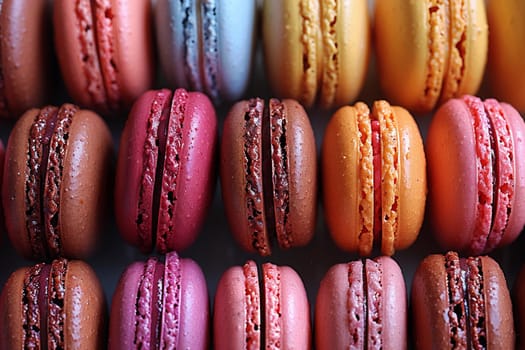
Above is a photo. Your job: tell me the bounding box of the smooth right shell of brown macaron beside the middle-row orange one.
[282,100,317,246]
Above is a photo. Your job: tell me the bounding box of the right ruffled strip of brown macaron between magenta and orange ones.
[263,99,293,248]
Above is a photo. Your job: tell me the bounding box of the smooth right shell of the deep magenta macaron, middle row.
[164,92,218,251]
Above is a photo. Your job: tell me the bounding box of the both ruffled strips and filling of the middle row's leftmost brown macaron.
[25,104,77,258]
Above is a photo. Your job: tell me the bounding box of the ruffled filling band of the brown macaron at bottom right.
[445,252,487,349]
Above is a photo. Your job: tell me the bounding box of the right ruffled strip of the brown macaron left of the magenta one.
[41,104,77,257]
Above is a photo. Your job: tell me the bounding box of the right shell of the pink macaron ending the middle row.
[499,103,525,246]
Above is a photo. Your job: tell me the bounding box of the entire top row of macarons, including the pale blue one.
[0,0,525,118]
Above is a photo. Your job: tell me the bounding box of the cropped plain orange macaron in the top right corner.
[487,0,525,113]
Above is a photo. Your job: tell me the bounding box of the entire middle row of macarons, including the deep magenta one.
[2,89,525,260]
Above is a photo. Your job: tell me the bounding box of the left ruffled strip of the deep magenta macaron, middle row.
[135,91,171,252]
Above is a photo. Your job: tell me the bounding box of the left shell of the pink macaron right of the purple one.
[213,263,262,350]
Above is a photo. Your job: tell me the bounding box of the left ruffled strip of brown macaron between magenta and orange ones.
[243,98,270,255]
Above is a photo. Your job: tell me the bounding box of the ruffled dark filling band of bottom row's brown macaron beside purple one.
[22,259,67,349]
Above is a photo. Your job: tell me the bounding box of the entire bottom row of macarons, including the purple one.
[0,252,525,350]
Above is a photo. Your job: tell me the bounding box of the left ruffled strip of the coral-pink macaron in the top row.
[75,0,106,109]
